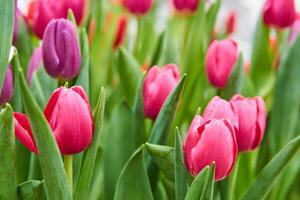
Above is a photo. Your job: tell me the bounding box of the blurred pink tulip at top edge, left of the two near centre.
[123,0,152,15]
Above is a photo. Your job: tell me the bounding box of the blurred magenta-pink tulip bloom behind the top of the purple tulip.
[26,0,86,39]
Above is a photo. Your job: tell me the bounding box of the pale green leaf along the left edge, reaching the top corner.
[0,0,14,91]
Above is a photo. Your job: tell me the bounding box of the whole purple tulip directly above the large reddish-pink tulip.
[42,19,81,79]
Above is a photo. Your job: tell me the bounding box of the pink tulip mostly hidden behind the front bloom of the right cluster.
[203,96,239,130]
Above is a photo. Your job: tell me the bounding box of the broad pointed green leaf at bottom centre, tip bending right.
[114,146,153,200]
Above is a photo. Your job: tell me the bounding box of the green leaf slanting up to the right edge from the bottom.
[241,136,300,200]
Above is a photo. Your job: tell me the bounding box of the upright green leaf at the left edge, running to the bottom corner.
[0,104,17,200]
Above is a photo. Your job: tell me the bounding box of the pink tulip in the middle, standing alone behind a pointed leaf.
[143,64,180,120]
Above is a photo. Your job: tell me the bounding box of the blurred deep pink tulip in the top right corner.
[263,0,297,29]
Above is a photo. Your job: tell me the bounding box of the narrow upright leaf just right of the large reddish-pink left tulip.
[74,88,105,199]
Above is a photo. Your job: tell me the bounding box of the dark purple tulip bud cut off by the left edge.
[0,65,14,106]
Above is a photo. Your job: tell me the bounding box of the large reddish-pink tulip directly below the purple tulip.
[44,86,93,154]
